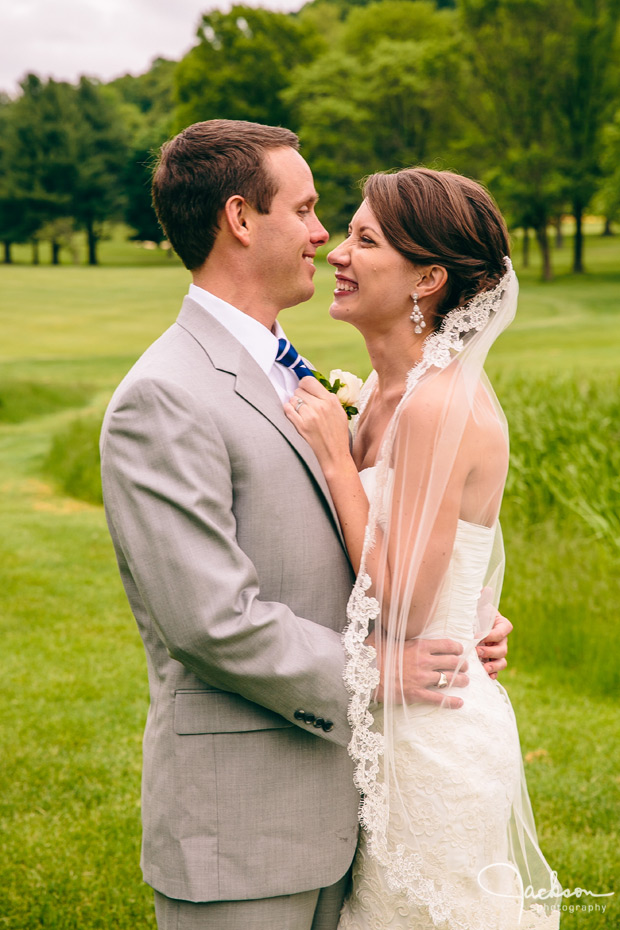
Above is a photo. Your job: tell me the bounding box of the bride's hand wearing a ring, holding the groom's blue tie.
[284,376,351,477]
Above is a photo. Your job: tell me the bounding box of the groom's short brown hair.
[152,119,299,271]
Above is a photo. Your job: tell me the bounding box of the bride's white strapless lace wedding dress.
[338,468,559,930]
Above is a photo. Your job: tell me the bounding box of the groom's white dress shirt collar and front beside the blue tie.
[189,284,311,403]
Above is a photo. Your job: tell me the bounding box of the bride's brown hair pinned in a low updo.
[363,168,510,327]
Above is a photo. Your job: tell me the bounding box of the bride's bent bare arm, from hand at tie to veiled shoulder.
[284,377,468,639]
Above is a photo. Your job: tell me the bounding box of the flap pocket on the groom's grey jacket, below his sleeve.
[174,690,293,736]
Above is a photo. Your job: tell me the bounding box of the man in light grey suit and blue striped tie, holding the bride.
[101,120,510,930]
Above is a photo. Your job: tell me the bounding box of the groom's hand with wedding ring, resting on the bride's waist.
[366,633,468,709]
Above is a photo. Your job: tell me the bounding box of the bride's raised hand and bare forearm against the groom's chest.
[284,377,368,574]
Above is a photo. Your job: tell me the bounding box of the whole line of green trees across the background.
[0,0,620,278]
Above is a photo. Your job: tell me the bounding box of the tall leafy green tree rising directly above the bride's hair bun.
[459,0,568,279]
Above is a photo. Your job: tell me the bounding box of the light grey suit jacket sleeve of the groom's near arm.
[101,379,350,745]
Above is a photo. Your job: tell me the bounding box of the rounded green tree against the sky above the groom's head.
[175,6,321,129]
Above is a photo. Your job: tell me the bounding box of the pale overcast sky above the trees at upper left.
[0,0,303,95]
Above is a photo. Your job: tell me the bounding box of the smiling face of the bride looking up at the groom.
[327,201,420,331]
